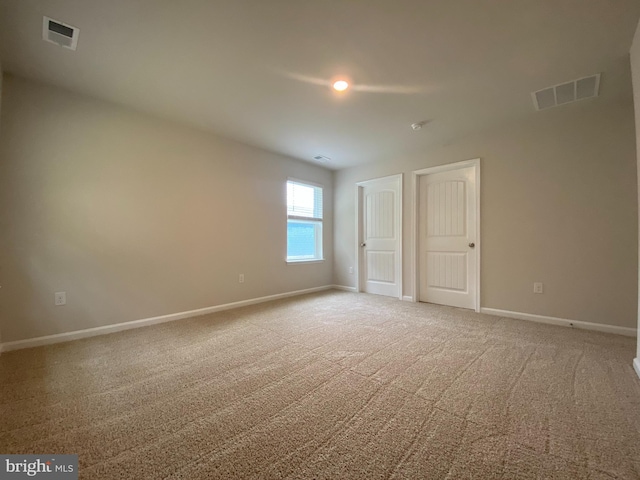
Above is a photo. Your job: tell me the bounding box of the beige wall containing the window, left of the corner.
[0,76,333,342]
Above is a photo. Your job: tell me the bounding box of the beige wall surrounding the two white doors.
[334,100,638,328]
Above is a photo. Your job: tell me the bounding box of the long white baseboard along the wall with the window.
[0,285,334,352]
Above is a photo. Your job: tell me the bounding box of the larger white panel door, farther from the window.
[418,167,478,309]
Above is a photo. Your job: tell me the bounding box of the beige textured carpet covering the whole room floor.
[0,292,640,480]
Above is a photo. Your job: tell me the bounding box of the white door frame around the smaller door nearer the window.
[355,173,403,300]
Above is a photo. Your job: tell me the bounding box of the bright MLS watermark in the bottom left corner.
[0,455,78,480]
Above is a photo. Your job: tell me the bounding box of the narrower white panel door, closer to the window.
[360,177,401,297]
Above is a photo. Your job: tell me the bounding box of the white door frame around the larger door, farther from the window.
[411,158,482,312]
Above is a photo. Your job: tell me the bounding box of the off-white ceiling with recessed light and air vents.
[0,0,640,168]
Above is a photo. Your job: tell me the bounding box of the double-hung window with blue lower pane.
[287,180,322,262]
